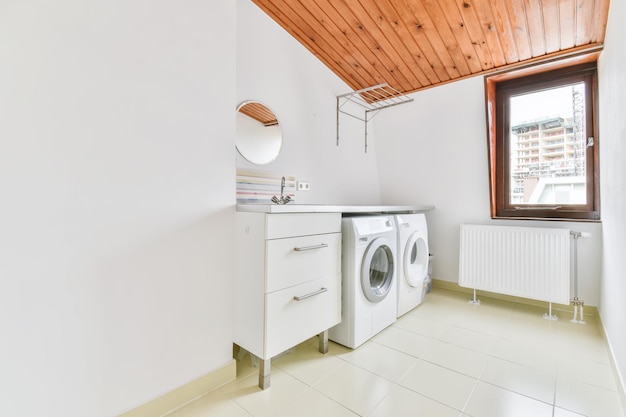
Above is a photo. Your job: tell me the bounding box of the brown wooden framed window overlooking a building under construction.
[486,58,600,221]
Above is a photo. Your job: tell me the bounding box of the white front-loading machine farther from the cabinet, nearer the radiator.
[395,213,428,317]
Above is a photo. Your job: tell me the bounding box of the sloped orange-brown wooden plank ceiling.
[252,0,609,93]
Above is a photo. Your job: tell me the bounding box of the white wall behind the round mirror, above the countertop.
[233,0,380,204]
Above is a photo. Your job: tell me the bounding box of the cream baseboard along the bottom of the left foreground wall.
[118,359,237,417]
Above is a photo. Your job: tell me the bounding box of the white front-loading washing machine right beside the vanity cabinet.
[328,216,398,349]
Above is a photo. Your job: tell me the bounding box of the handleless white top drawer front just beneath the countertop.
[265,213,341,239]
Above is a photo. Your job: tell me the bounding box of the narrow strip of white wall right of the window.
[599,1,626,394]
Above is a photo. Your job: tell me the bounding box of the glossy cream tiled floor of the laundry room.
[171,289,624,417]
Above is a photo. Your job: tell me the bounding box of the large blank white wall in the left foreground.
[0,0,236,417]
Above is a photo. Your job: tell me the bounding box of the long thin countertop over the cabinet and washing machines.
[237,204,435,214]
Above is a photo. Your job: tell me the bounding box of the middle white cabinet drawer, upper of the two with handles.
[265,233,341,292]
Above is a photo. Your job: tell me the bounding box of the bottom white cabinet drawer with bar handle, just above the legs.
[265,274,341,358]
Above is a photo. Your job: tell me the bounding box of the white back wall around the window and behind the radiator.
[374,77,602,306]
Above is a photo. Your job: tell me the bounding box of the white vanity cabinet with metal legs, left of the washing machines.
[233,212,341,389]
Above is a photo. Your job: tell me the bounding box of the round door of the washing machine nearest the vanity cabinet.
[361,237,394,303]
